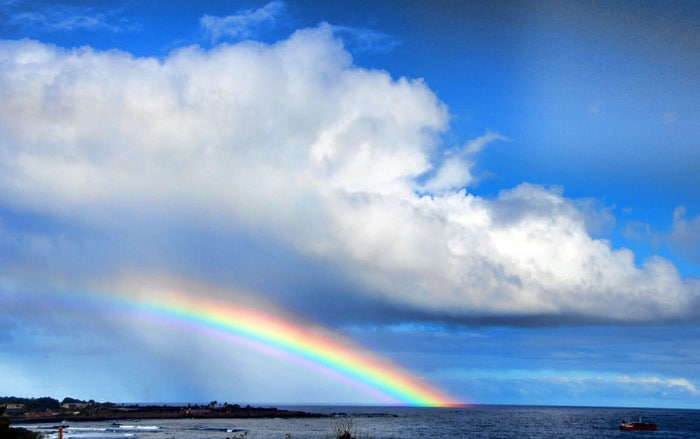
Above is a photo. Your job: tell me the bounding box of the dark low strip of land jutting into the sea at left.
[0,396,323,424]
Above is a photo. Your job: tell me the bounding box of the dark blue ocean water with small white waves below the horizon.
[22,405,700,439]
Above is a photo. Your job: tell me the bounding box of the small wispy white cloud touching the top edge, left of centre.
[199,1,286,42]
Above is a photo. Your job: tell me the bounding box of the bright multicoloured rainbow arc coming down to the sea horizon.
[95,278,463,407]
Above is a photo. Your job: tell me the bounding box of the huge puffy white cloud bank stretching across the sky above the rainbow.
[0,24,700,322]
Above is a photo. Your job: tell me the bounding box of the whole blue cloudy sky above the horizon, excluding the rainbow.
[0,0,700,408]
